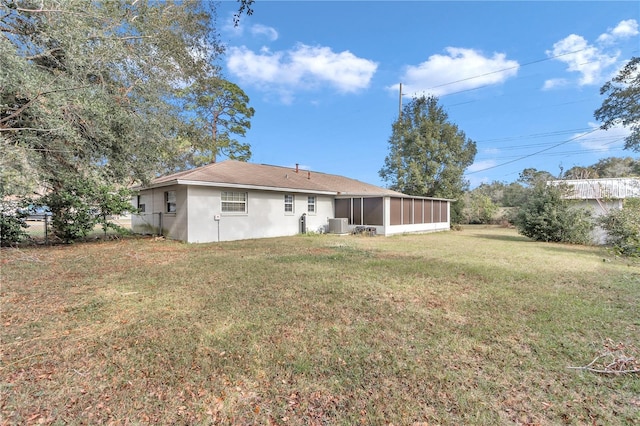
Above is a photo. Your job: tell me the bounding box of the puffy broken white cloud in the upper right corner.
[544,19,639,89]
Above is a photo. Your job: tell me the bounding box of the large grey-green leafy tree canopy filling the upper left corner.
[0,0,221,193]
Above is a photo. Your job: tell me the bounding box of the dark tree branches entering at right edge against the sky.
[594,57,640,152]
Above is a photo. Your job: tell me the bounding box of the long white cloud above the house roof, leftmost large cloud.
[227,44,378,100]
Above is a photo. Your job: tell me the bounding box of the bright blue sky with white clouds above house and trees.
[212,0,640,187]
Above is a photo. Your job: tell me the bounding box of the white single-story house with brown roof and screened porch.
[131,160,452,243]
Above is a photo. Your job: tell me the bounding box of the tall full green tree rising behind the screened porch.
[379,96,477,223]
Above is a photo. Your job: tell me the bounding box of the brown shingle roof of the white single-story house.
[149,160,405,196]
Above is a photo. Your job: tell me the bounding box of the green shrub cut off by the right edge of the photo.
[599,199,640,257]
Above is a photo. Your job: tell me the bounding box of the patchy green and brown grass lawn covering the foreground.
[0,228,640,425]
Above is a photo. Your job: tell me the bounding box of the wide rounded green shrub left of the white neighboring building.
[514,184,594,244]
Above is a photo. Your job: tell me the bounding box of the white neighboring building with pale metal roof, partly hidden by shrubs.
[548,178,640,244]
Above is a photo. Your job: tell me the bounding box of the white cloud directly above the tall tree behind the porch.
[389,47,520,96]
